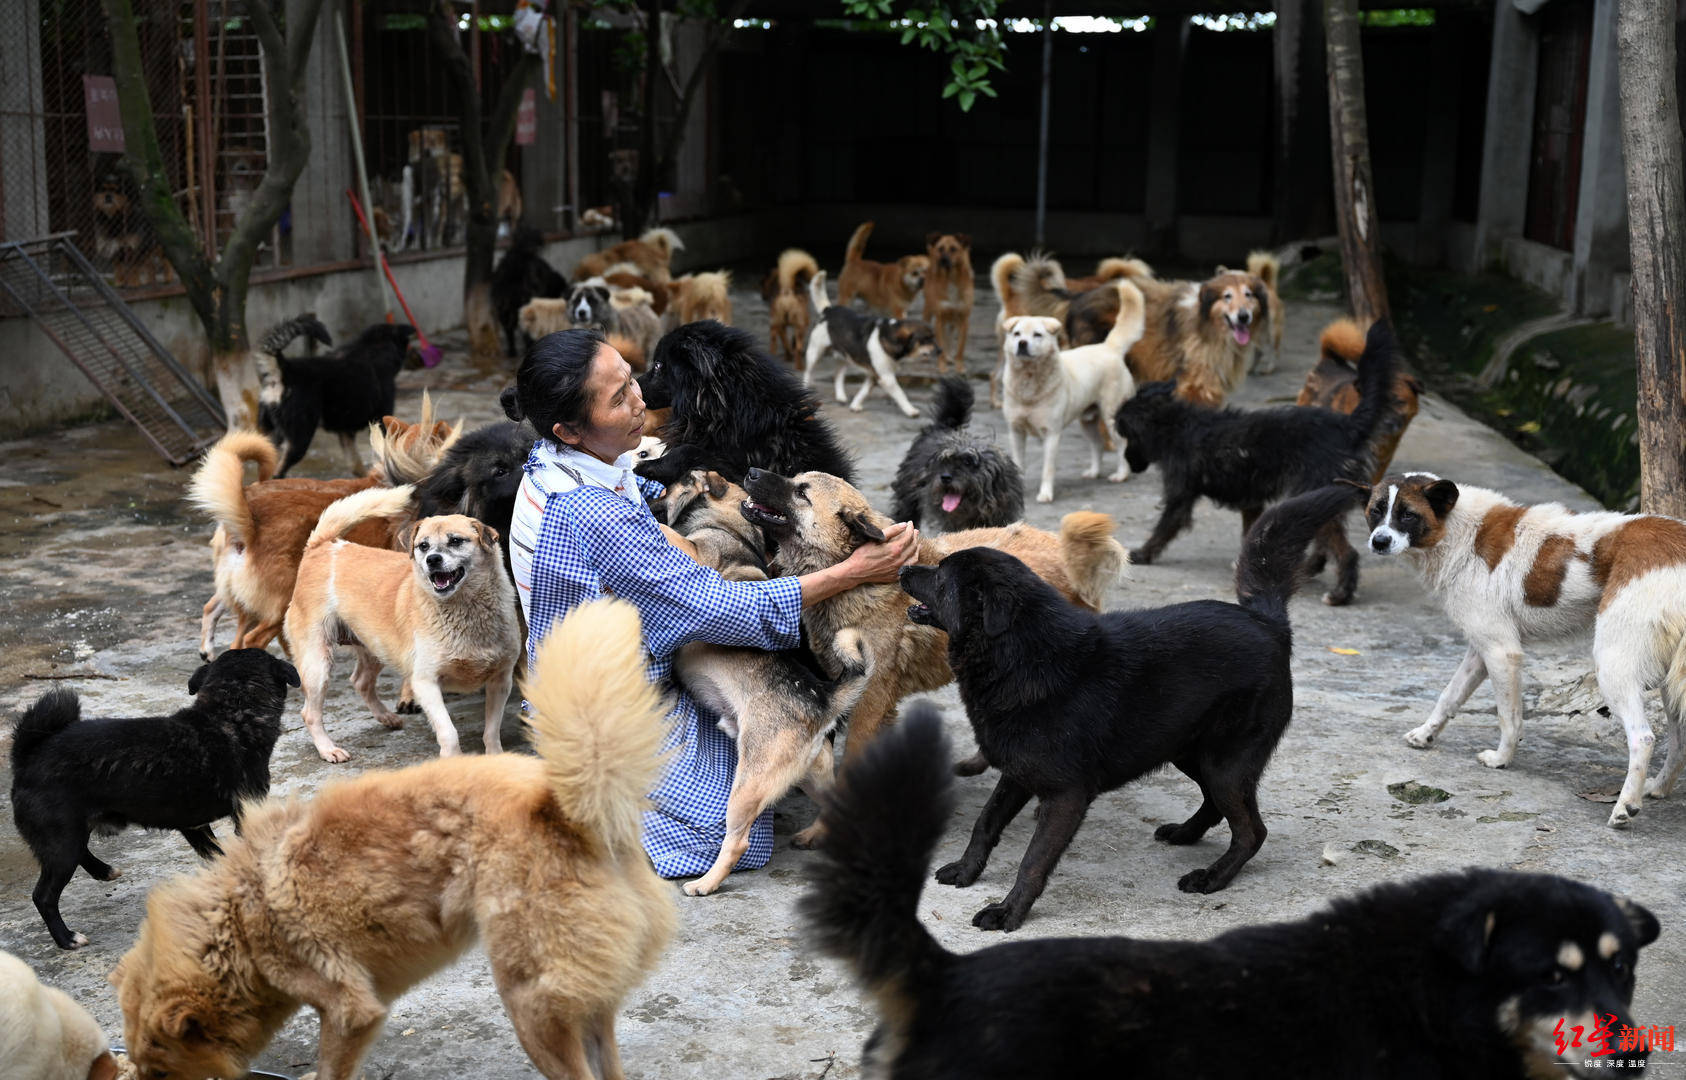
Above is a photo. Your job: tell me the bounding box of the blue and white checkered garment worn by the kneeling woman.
[509,441,803,878]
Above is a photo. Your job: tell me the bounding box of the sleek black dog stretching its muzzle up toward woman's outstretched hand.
[902,484,1361,930]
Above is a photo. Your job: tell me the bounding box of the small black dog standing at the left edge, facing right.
[12,649,298,949]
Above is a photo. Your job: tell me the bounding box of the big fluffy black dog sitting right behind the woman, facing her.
[637,320,855,484]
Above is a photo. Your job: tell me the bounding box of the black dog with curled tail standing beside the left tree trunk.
[260,315,416,477]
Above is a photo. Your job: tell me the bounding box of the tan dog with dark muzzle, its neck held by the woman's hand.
[744,470,1128,805]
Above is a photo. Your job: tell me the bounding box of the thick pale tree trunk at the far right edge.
[1615,0,1686,517]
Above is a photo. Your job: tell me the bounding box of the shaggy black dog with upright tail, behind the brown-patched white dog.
[1118,322,1398,605]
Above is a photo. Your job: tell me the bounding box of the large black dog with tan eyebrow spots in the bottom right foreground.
[801,703,1659,1080]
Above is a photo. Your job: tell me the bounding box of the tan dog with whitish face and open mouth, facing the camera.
[287,487,521,762]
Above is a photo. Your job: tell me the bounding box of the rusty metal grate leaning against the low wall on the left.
[0,233,226,465]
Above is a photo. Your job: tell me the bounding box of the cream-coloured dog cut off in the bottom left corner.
[0,952,118,1080]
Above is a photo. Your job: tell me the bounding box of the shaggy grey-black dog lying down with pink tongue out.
[890,376,1025,534]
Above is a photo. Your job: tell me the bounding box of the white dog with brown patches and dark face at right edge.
[1366,472,1686,826]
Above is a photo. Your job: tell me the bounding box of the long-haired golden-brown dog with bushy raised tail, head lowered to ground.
[111,600,674,1080]
